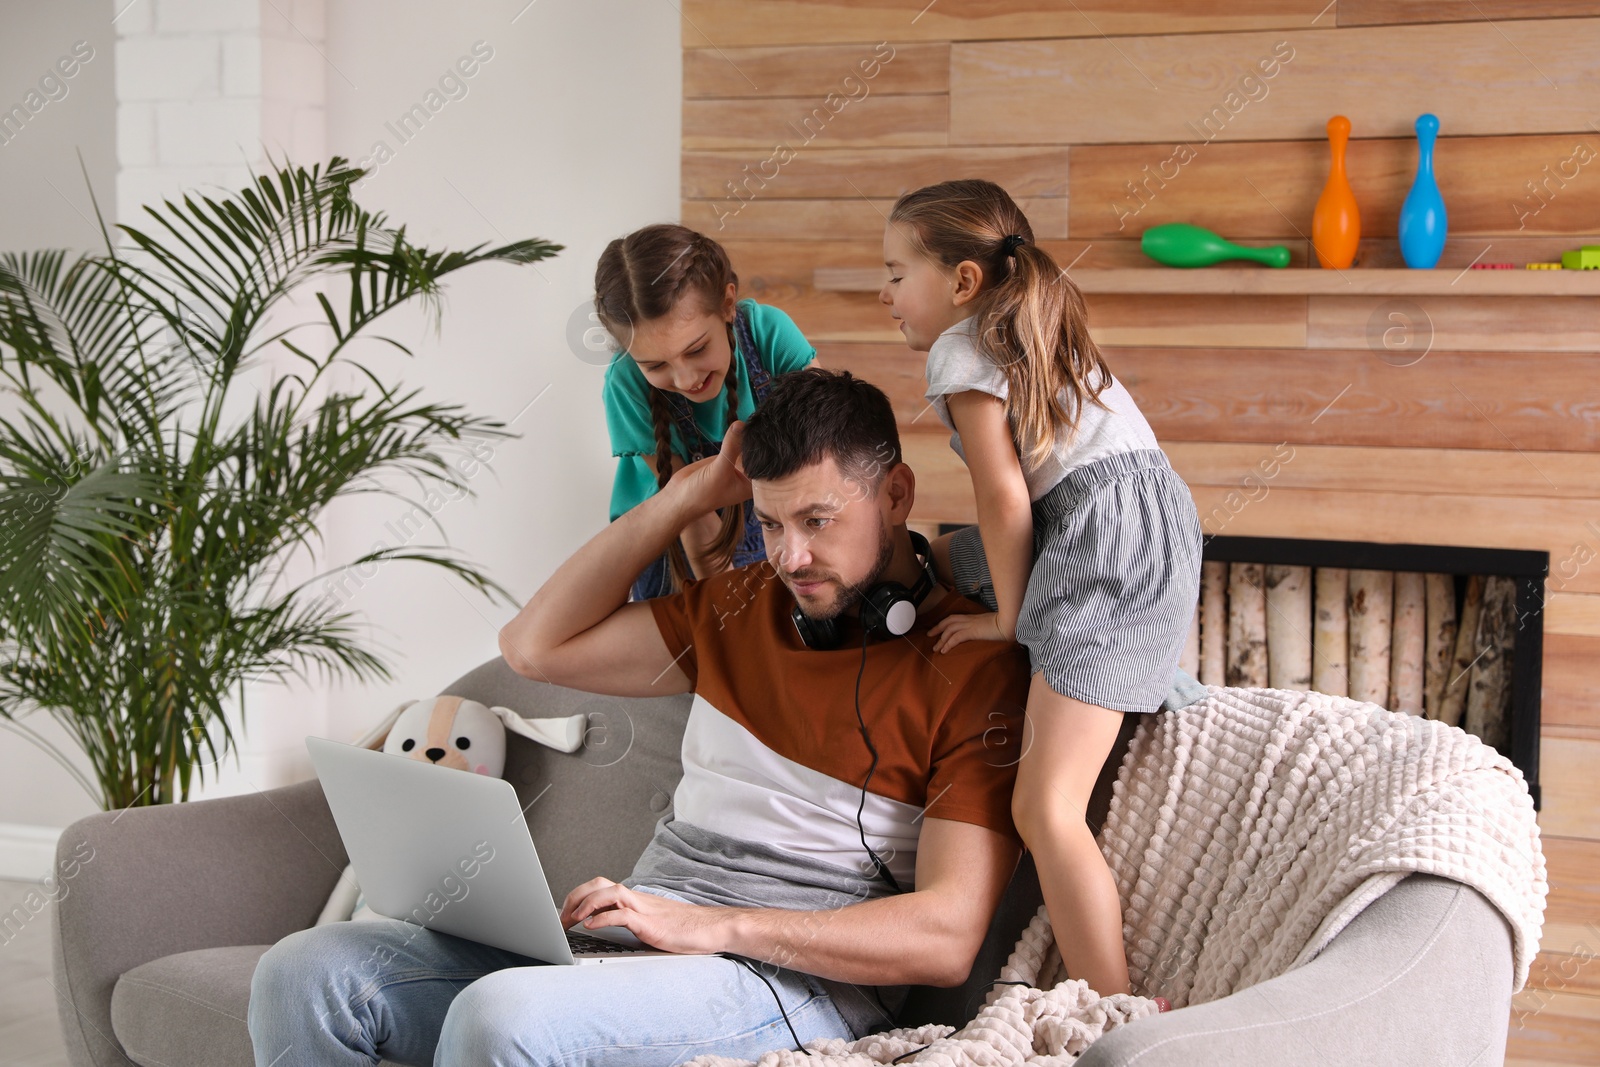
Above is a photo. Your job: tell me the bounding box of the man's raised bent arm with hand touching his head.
[499,422,750,696]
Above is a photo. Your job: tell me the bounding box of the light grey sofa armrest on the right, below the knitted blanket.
[1078,873,1512,1067]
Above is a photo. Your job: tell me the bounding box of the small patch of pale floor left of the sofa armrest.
[0,878,67,1067]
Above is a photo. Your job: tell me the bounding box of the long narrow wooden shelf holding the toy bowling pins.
[811,267,1600,296]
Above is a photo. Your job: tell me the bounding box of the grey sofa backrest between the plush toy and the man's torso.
[440,657,693,904]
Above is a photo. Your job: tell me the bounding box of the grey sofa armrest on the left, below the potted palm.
[51,781,347,1067]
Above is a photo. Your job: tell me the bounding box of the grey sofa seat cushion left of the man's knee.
[110,945,270,1067]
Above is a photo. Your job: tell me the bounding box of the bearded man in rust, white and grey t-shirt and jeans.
[250,368,1029,1067]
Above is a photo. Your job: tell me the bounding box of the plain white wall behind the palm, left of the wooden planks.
[0,0,682,870]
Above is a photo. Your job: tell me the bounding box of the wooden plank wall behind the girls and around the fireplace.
[682,0,1600,1064]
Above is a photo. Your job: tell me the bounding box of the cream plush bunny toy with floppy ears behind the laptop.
[317,696,584,926]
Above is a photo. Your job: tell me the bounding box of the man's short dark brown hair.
[741,366,901,493]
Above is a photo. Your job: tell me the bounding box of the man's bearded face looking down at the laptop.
[750,456,894,619]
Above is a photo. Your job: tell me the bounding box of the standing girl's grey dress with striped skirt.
[926,317,1205,712]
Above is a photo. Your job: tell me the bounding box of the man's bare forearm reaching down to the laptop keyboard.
[562,817,1021,985]
